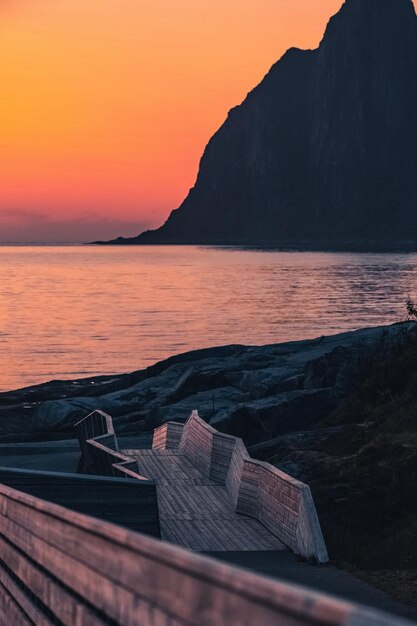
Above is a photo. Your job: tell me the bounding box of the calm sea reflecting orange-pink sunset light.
[0,247,417,390]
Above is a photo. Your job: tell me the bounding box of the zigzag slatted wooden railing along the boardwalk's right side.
[154,411,328,563]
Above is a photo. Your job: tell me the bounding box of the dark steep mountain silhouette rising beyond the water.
[103,0,417,248]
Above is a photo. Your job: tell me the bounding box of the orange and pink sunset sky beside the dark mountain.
[0,0,376,243]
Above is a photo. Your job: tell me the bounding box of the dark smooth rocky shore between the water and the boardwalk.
[0,324,408,438]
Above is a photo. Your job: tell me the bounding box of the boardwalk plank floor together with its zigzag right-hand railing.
[124,411,328,563]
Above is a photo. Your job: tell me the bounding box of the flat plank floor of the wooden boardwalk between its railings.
[123,449,287,552]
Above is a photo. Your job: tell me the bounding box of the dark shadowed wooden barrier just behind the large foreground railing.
[0,467,161,538]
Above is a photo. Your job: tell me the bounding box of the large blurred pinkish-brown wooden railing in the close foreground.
[0,486,407,626]
